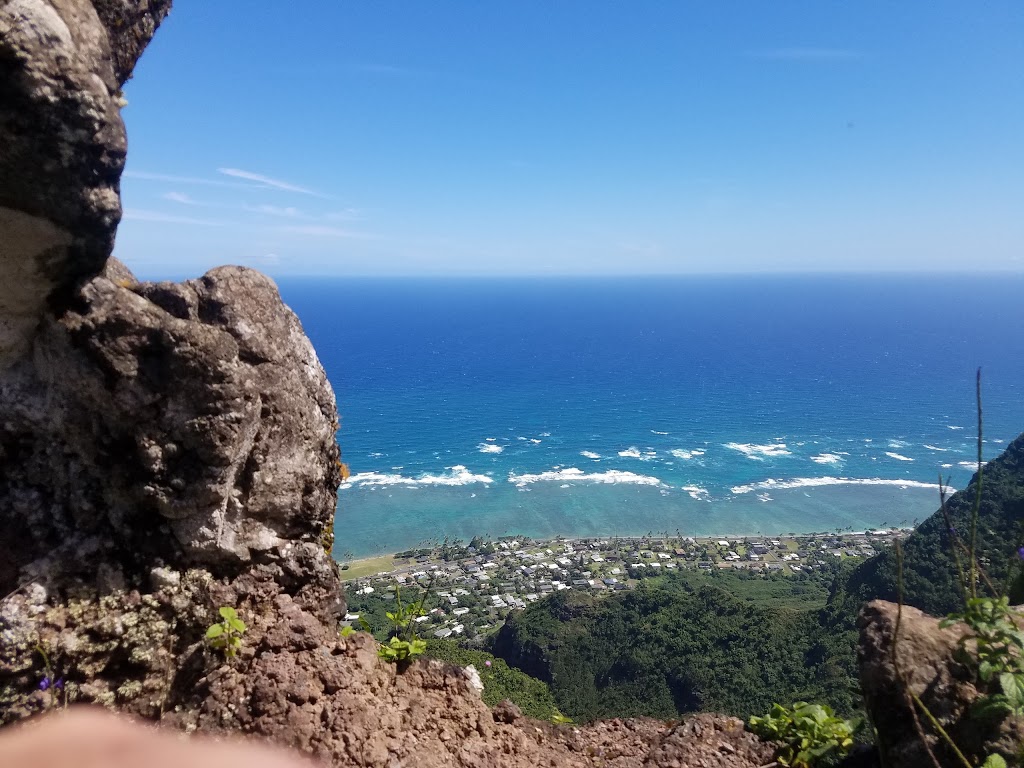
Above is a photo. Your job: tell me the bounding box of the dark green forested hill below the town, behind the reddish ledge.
[492,564,857,720]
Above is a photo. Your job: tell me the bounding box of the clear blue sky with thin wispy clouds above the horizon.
[115,0,1024,279]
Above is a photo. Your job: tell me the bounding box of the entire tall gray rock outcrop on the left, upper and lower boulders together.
[0,0,344,721]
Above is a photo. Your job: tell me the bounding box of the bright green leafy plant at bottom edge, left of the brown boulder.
[750,701,854,768]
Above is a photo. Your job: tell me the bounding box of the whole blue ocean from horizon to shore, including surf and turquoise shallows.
[281,275,1024,556]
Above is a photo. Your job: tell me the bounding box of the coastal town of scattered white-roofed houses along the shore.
[341,528,910,639]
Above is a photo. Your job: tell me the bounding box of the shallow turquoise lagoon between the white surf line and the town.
[334,481,939,560]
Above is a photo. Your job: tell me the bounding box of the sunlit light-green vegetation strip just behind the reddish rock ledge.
[426,640,561,720]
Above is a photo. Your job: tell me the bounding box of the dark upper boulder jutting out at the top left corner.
[0,0,171,368]
